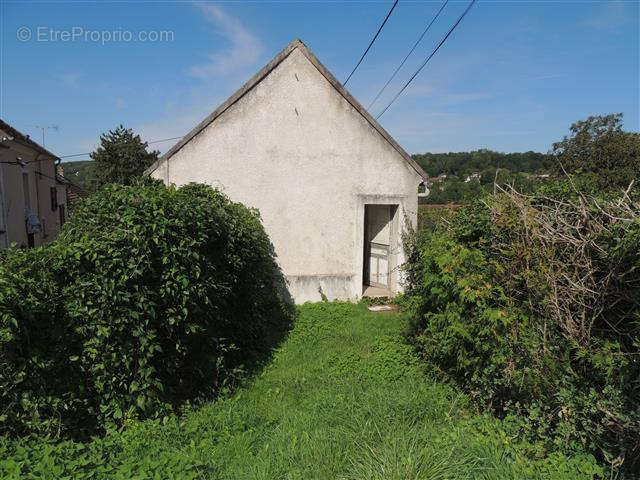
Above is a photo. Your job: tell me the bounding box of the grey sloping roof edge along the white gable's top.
[144,38,429,180]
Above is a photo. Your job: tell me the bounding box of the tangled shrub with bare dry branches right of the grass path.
[405,186,640,472]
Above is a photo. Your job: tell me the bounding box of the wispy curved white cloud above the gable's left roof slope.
[189,5,263,78]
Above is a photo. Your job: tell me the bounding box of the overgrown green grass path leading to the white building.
[0,303,600,480]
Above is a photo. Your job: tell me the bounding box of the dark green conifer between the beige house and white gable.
[91,125,160,188]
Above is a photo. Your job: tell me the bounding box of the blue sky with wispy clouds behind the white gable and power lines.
[0,0,640,159]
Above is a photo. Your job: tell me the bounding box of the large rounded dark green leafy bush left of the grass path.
[0,180,292,436]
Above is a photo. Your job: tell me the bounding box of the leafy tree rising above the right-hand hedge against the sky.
[553,113,640,188]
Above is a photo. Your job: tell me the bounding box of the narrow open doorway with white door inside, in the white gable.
[362,205,397,297]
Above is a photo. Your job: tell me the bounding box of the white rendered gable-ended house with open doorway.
[147,40,427,303]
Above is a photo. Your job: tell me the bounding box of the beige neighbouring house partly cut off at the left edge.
[0,120,67,248]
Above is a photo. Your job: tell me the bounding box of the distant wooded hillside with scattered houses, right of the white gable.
[413,149,553,178]
